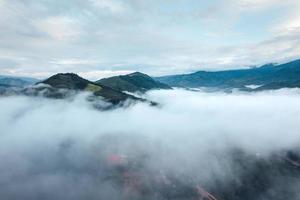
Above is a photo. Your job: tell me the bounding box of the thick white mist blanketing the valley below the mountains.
[0,89,300,200]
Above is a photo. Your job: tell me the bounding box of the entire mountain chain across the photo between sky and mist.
[0,60,300,101]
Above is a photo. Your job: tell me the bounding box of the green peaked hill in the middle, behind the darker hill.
[96,72,171,92]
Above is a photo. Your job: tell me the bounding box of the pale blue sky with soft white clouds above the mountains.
[0,0,300,80]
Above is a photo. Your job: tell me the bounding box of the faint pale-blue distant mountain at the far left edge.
[0,76,38,88]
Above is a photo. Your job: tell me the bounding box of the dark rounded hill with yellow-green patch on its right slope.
[24,73,143,104]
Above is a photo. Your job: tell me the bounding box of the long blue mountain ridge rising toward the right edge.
[155,60,300,90]
